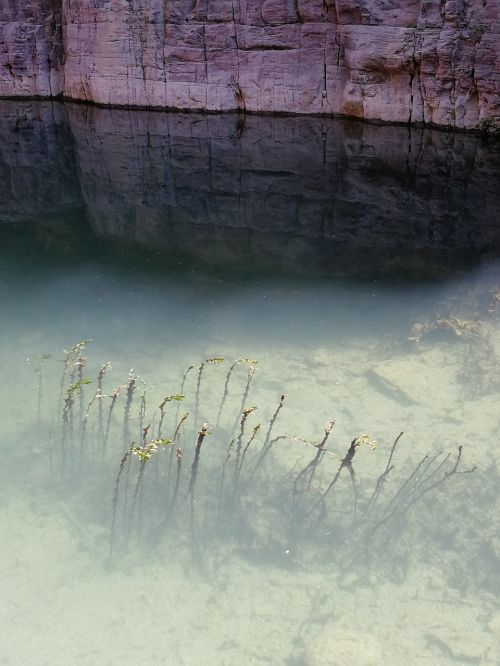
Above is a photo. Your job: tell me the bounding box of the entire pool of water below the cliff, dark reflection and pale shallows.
[0,103,500,666]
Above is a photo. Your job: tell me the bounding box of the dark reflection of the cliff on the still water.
[0,102,500,275]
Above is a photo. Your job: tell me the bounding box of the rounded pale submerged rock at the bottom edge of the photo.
[305,624,384,666]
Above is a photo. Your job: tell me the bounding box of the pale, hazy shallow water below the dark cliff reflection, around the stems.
[0,101,500,665]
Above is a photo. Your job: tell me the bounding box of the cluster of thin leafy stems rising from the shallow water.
[36,340,473,562]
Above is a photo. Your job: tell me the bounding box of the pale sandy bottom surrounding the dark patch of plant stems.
[0,268,500,666]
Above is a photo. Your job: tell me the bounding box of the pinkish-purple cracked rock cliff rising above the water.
[0,0,500,131]
